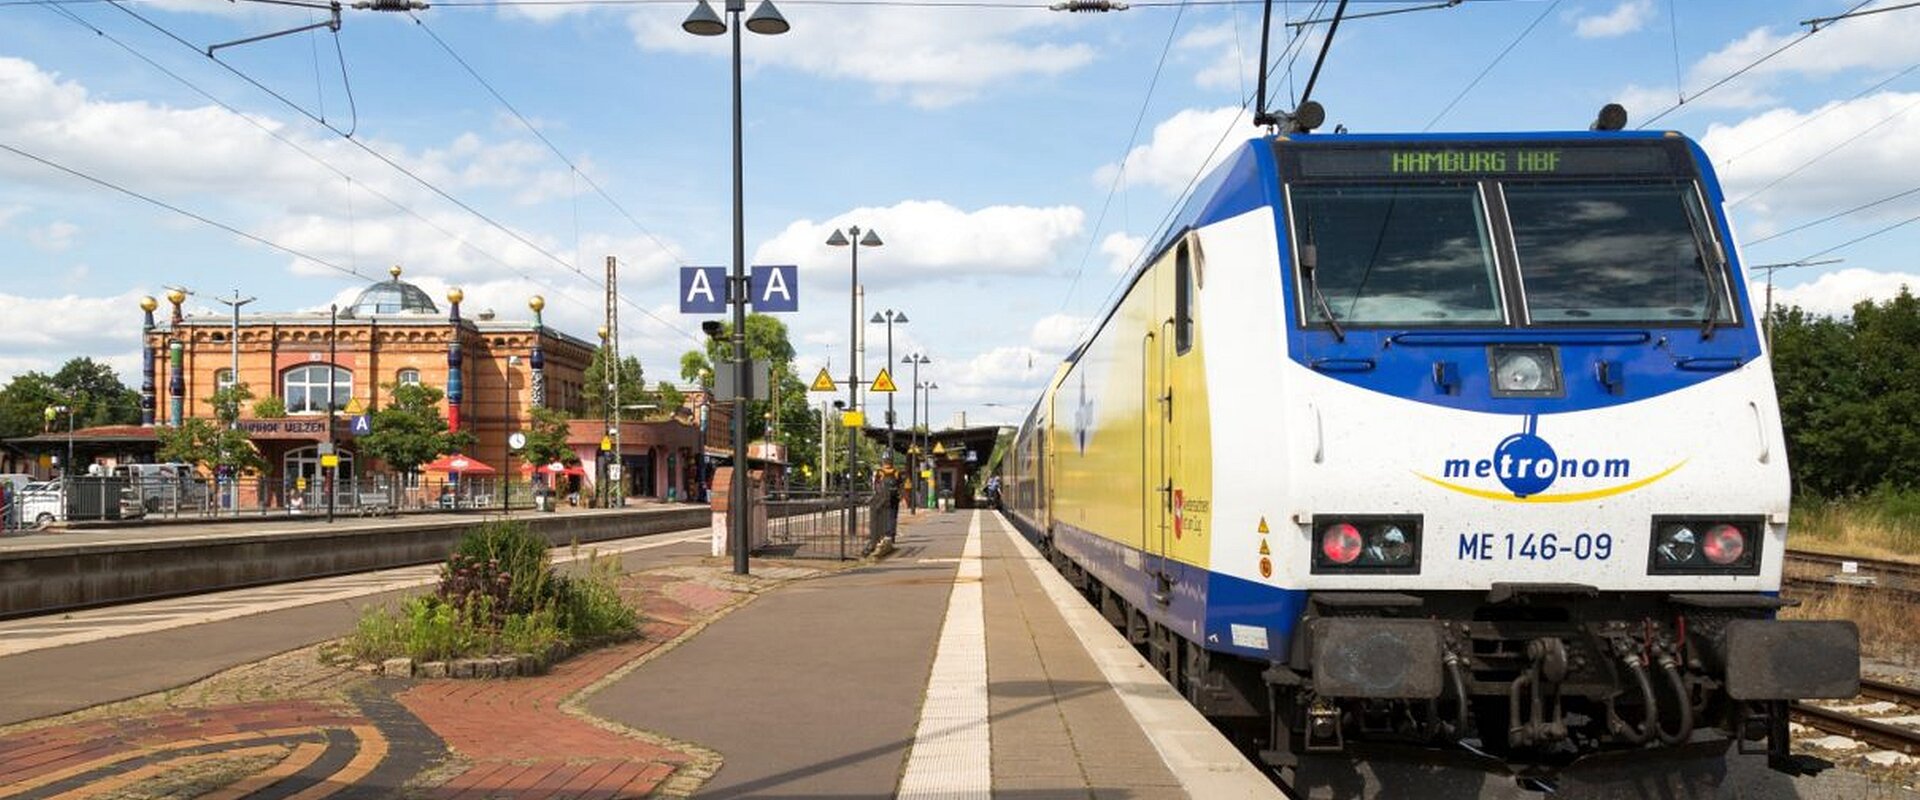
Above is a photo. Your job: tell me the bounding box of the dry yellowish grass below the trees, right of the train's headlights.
[1788,489,1920,560]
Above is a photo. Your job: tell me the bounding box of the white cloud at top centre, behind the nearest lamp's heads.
[628,6,1094,107]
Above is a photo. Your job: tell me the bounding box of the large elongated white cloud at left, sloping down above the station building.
[0,58,622,289]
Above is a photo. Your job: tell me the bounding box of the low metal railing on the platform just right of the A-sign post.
[758,491,897,558]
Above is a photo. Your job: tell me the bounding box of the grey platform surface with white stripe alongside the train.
[586,512,1279,798]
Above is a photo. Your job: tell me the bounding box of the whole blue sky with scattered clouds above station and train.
[0,0,1920,426]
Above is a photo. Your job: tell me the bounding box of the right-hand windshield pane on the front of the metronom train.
[1503,180,1734,324]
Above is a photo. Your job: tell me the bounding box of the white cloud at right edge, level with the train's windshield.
[1699,92,1920,226]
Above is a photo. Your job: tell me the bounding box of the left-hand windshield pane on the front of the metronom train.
[1292,184,1505,324]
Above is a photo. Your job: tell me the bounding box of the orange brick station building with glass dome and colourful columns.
[129,267,726,505]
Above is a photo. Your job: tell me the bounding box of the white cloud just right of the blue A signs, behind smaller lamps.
[753,200,1087,288]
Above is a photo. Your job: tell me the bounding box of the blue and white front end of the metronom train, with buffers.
[1244,132,1859,773]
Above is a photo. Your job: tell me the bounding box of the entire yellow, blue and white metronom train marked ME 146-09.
[1002,107,1859,779]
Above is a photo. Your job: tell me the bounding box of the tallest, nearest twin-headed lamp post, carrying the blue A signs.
[680,0,793,576]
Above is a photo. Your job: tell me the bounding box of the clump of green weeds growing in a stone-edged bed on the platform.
[348,522,639,662]
